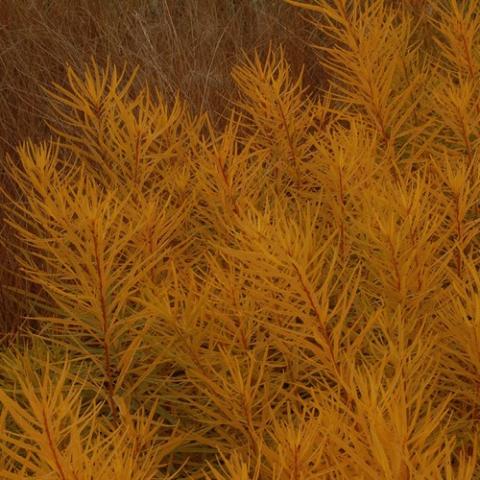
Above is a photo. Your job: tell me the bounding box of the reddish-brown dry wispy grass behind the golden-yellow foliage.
[0,0,326,338]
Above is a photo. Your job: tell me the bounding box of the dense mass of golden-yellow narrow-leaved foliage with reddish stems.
[0,0,480,480]
